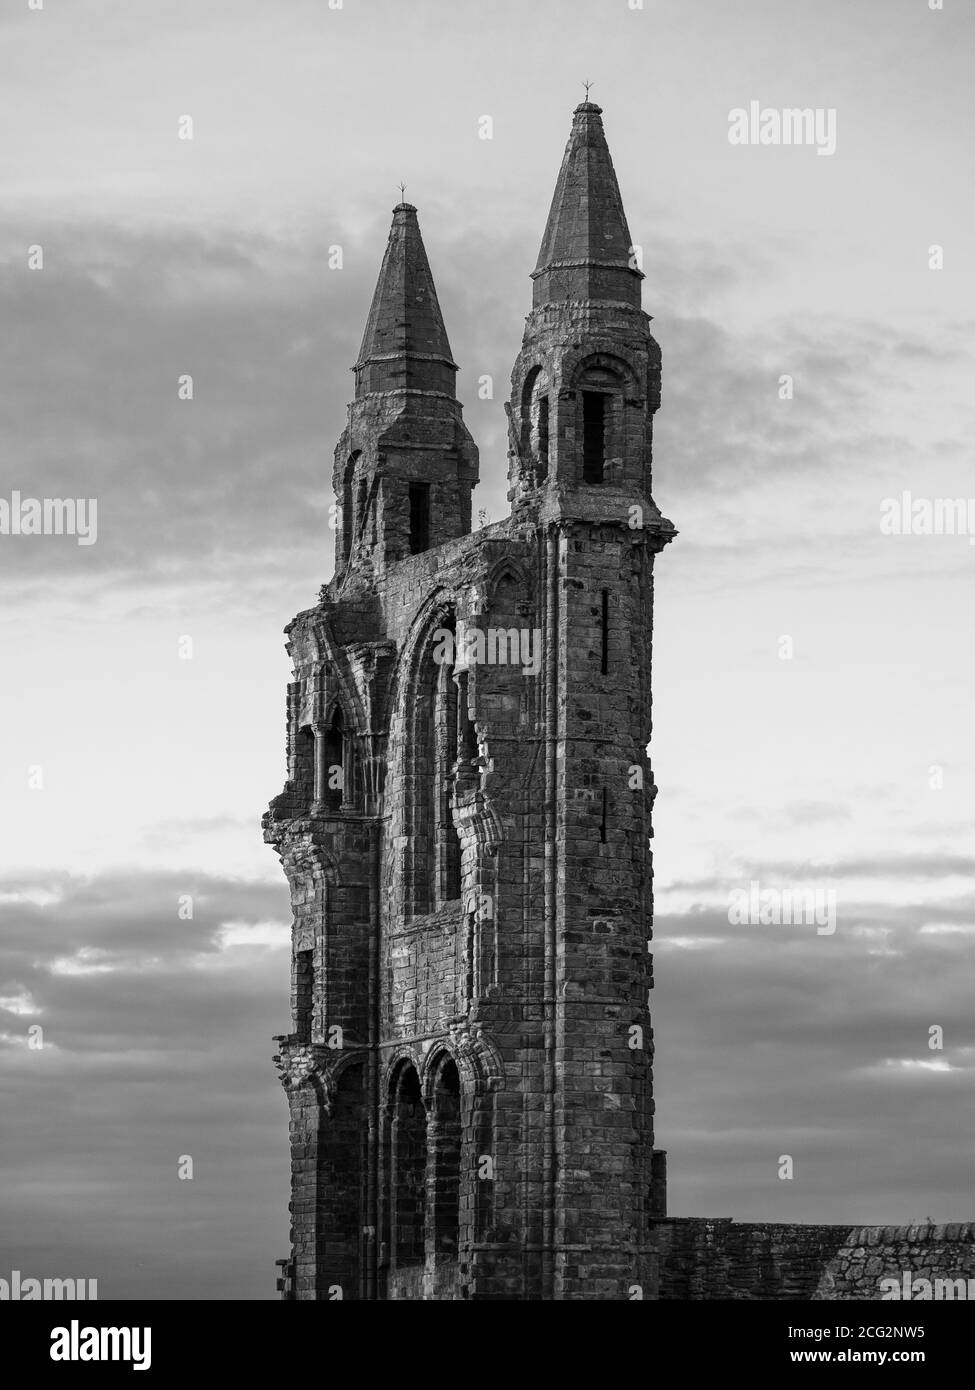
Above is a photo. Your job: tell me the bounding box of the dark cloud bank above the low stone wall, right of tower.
[651,897,975,1223]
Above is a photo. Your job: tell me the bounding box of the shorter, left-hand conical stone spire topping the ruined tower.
[353,203,458,398]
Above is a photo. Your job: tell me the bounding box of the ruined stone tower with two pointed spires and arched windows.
[264,101,675,1300]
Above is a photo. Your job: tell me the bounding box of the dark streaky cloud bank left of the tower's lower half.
[0,873,291,1298]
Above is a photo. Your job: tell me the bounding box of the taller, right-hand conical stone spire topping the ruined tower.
[531,101,643,309]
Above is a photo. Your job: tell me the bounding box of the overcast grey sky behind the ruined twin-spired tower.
[0,0,975,1298]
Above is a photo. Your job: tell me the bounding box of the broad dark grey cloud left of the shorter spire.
[0,225,364,597]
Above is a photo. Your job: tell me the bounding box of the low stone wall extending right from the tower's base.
[654,1218,975,1301]
